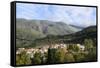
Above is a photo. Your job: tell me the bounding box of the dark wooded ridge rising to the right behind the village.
[34,26,97,46]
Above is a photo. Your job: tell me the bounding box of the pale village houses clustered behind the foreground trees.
[16,44,85,58]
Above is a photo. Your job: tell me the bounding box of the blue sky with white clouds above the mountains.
[16,3,96,27]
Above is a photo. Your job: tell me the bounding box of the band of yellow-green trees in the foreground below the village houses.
[16,39,97,65]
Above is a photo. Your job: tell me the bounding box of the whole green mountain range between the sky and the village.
[16,19,97,47]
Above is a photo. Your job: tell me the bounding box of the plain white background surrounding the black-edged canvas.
[0,0,100,68]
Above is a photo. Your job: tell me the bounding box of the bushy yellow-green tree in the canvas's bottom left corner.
[16,51,31,65]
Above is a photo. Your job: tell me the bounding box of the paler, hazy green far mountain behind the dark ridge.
[16,19,81,39]
